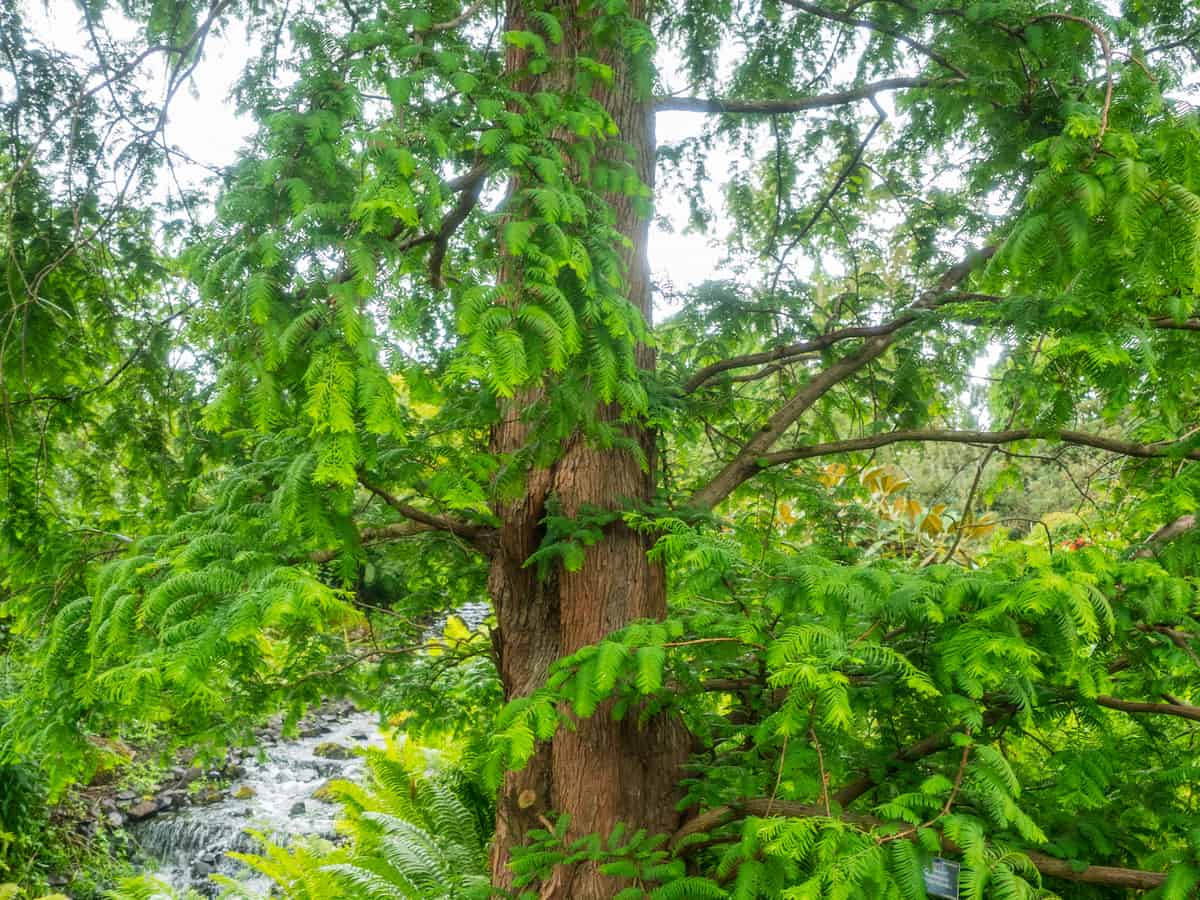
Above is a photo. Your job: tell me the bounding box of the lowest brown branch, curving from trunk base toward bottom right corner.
[671,797,1166,890]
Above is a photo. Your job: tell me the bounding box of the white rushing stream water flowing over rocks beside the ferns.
[132,710,384,896]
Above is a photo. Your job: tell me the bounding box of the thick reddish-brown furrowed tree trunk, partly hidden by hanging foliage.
[488,0,688,900]
